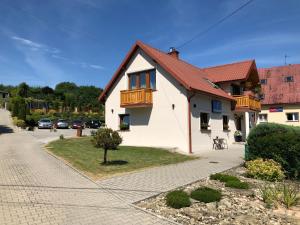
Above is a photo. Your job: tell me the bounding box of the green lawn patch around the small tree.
[47,137,196,179]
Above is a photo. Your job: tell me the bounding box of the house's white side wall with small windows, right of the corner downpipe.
[191,94,236,153]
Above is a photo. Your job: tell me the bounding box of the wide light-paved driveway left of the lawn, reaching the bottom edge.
[0,109,170,225]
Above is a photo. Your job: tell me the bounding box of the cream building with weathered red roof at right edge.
[258,64,300,126]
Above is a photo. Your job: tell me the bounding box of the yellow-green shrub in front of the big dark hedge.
[246,159,284,181]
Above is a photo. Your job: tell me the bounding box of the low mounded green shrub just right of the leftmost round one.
[191,187,222,203]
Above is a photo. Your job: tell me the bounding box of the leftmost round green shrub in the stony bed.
[166,190,191,209]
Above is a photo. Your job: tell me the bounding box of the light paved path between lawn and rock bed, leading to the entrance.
[97,144,244,203]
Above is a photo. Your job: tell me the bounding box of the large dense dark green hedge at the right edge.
[247,123,300,179]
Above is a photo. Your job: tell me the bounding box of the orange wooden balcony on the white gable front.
[120,88,152,108]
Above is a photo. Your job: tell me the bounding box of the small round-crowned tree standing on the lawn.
[92,128,122,164]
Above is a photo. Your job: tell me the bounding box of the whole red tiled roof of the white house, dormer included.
[99,41,256,101]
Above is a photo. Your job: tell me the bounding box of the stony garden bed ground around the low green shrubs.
[137,167,300,225]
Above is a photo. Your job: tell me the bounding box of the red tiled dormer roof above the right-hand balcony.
[203,60,255,83]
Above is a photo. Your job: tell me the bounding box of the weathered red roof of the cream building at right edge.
[258,64,300,105]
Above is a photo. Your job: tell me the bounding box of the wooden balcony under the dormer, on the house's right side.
[233,95,261,111]
